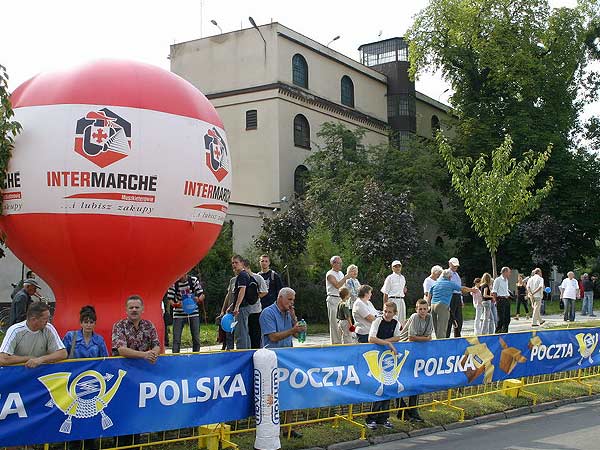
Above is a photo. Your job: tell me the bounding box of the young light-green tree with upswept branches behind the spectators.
[438,134,552,277]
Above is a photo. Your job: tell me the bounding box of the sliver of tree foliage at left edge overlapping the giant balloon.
[0,65,21,258]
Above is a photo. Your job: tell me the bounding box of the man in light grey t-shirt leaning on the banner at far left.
[0,302,67,368]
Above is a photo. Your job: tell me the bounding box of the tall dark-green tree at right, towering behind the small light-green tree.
[407,0,600,268]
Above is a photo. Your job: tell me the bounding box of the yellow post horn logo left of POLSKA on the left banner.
[38,370,127,434]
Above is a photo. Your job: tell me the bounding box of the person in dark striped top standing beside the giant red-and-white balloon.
[167,274,204,353]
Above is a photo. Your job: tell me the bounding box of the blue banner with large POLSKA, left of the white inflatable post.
[0,351,254,447]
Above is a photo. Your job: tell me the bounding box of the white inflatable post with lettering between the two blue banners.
[253,348,281,450]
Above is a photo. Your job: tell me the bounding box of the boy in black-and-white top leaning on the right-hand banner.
[366,301,400,430]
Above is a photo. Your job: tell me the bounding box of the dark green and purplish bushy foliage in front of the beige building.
[256,123,428,312]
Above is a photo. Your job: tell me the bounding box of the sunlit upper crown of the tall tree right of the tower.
[408,0,599,155]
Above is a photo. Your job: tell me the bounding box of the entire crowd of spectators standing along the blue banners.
[0,255,595,440]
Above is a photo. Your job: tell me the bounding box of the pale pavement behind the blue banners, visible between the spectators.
[175,314,589,353]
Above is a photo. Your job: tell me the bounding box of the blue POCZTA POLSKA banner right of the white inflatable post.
[276,328,600,410]
